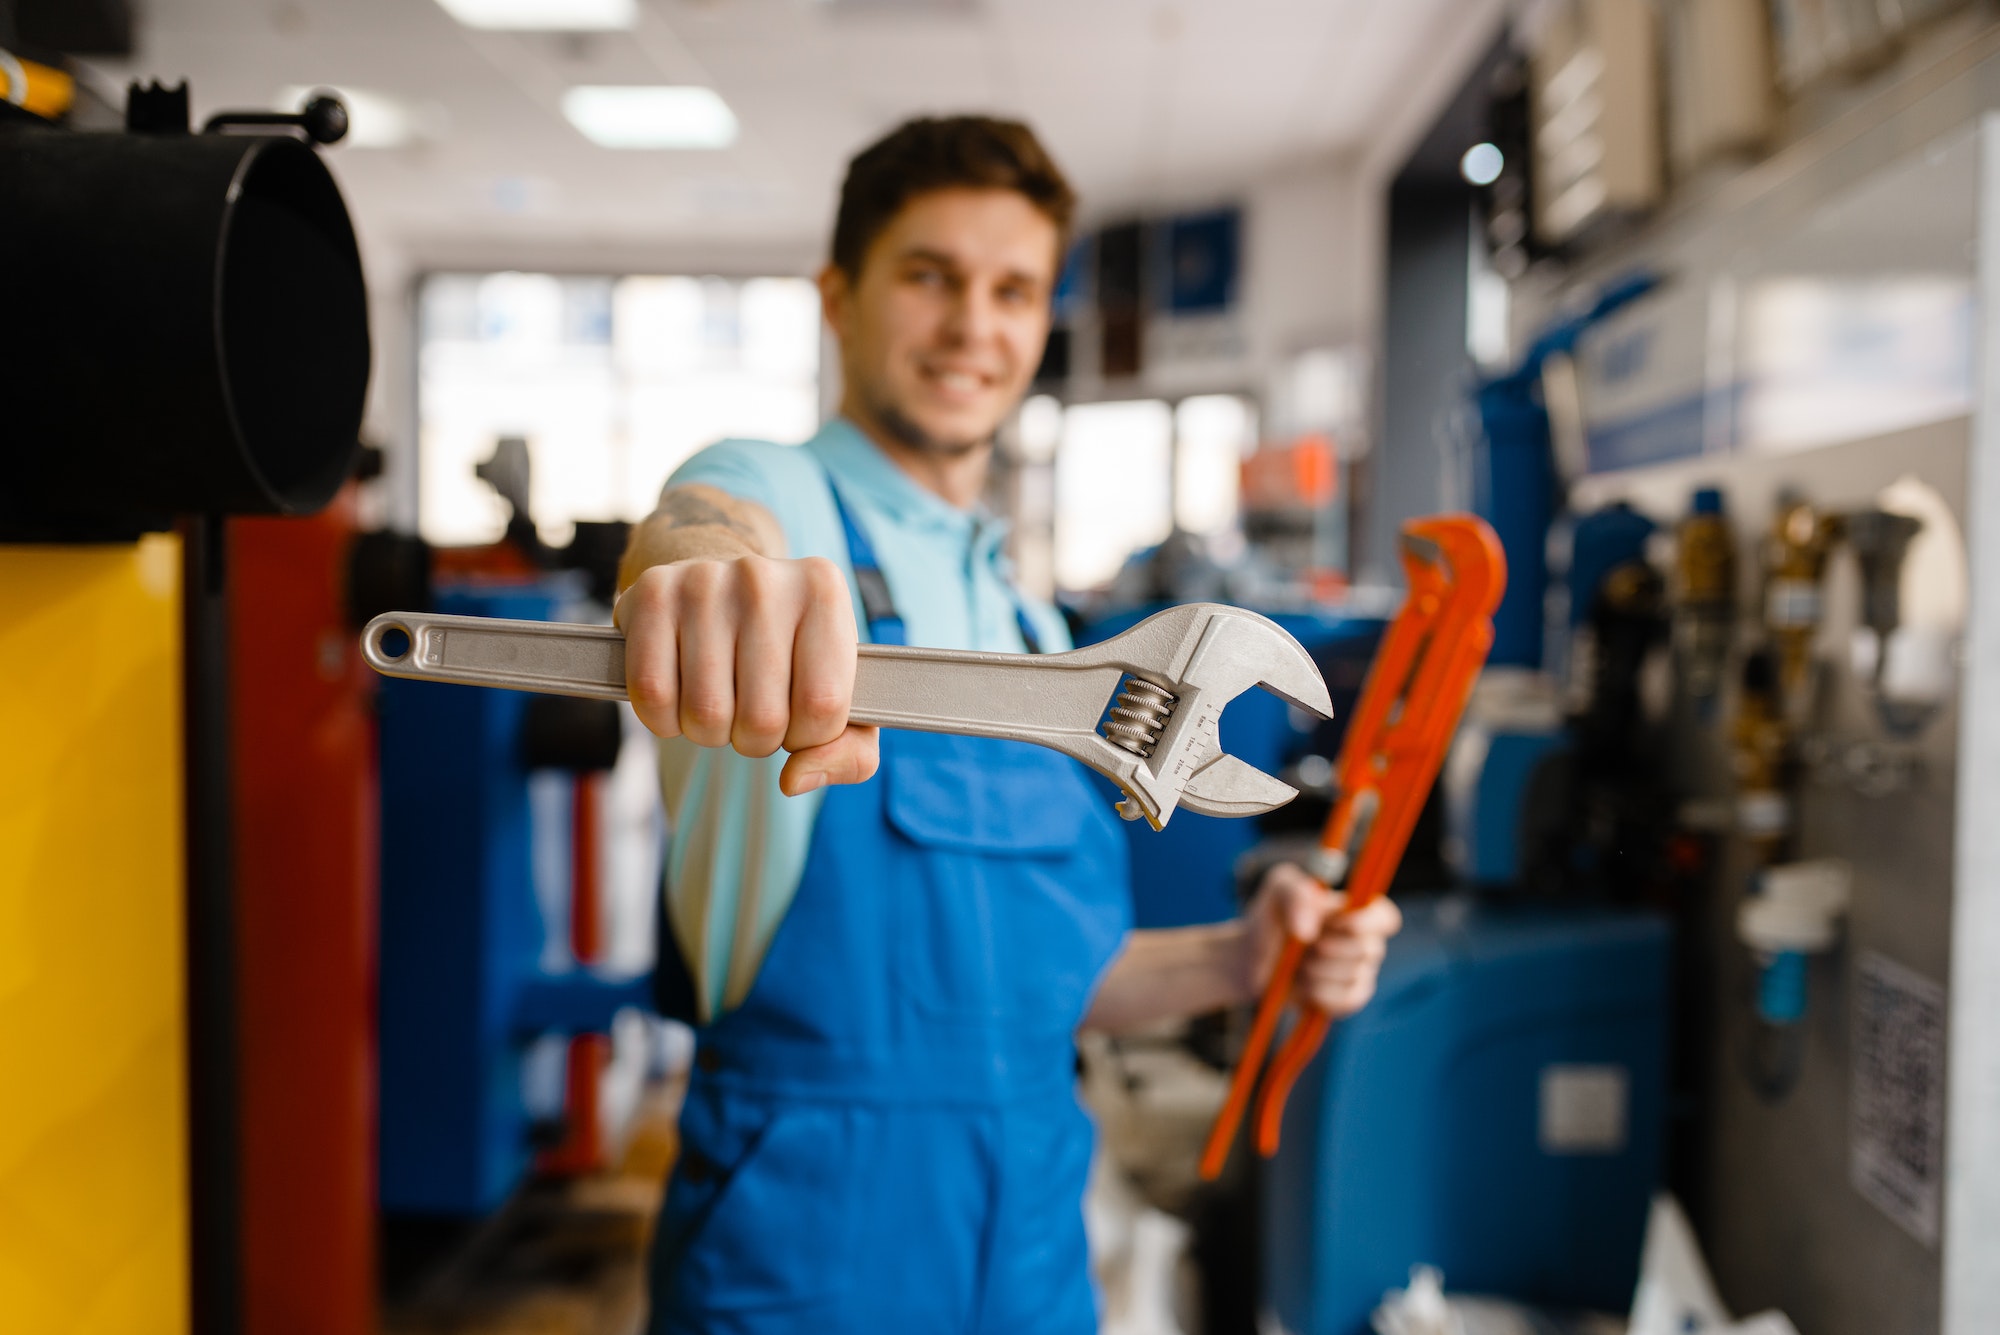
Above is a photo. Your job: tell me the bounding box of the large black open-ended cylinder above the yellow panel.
[0,118,368,526]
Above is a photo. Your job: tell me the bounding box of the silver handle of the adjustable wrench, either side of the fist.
[362,612,1124,743]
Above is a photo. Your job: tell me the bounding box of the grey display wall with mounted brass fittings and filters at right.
[1520,54,2000,1335]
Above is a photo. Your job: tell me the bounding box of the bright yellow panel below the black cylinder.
[0,536,188,1335]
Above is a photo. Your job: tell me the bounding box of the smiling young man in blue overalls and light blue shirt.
[618,118,1400,1333]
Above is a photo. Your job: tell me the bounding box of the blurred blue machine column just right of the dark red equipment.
[378,586,648,1215]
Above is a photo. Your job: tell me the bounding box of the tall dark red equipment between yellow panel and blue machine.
[228,484,376,1335]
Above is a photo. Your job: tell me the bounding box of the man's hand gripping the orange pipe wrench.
[1244,863,1402,1019]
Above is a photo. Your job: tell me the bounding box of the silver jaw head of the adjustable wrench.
[1110,604,1332,829]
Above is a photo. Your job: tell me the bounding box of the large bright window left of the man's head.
[418,274,820,544]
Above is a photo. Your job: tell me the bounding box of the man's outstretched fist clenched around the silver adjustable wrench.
[614,556,876,797]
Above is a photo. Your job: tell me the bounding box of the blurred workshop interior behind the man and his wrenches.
[0,0,2000,1335]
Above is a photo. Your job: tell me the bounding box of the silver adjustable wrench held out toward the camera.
[362,604,1332,829]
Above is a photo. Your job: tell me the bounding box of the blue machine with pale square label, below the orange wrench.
[1264,899,1668,1335]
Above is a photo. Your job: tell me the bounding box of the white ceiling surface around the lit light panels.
[82,0,1488,273]
